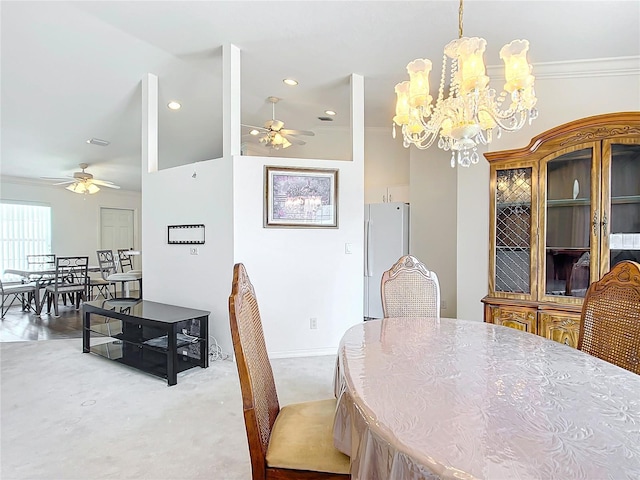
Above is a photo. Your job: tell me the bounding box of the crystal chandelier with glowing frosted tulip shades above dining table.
[393,0,538,167]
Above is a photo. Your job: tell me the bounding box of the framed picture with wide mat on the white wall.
[264,166,338,228]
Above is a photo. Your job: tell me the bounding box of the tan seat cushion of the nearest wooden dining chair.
[267,399,349,474]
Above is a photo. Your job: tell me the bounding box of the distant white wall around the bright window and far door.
[0,177,142,265]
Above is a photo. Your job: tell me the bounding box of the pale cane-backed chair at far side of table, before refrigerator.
[380,255,440,318]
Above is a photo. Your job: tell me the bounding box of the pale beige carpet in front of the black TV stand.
[0,339,335,480]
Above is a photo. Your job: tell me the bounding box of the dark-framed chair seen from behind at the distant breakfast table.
[45,257,89,317]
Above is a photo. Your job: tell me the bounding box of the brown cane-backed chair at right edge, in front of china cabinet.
[578,260,640,374]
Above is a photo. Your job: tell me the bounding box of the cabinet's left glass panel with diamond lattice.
[494,167,532,294]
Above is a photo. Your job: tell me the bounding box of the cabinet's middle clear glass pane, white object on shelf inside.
[544,144,597,297]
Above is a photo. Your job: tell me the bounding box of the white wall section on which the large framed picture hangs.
[234,157,364,357]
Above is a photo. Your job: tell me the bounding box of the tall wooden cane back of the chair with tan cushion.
[229,263,280,479]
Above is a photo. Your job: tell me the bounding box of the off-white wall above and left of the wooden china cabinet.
[457,57,640,320]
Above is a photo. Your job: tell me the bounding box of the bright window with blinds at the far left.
[0,201,51,270]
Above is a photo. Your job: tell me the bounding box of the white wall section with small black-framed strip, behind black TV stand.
[142,159,234,353]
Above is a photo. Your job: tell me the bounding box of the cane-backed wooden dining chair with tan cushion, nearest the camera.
[229,263,350,480]
